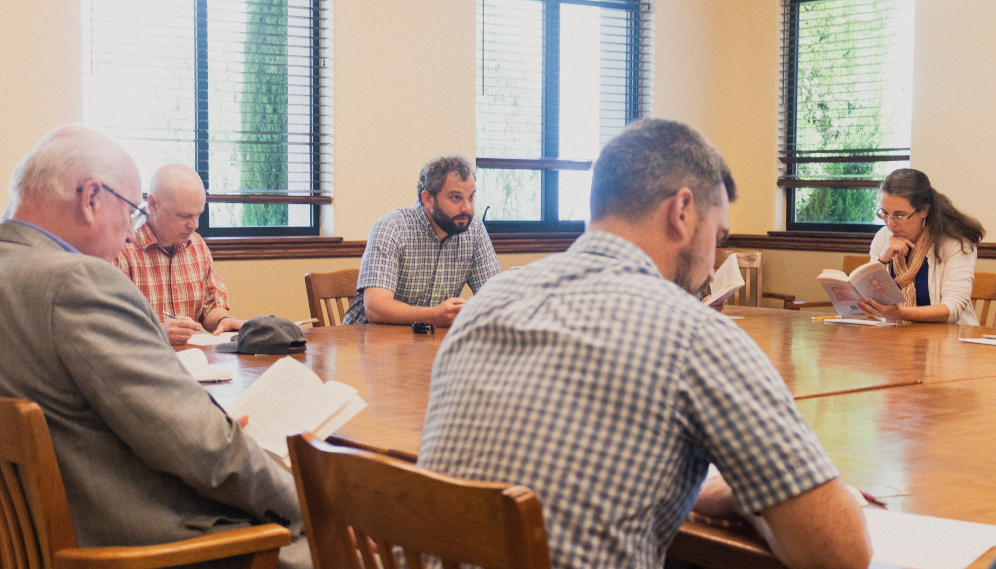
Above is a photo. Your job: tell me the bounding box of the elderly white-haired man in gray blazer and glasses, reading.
[0,126,311,567]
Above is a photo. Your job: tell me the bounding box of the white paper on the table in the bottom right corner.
[862,506,996,569]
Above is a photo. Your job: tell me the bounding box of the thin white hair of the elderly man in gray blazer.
[7,125,124,207]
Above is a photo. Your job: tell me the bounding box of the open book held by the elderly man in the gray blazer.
[226,356,367,467]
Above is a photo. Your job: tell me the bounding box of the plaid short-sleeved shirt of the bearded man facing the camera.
[342,202,501,324]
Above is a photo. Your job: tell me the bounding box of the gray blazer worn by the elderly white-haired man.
[0,222,301,547]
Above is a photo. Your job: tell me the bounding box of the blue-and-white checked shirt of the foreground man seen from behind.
[419,231,838,568]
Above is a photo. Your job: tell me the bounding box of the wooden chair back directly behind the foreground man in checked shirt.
[287,433,550,569]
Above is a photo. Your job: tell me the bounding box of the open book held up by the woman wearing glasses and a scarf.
[816,261,906,316]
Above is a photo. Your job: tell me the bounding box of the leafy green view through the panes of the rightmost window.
[795,0,911,223]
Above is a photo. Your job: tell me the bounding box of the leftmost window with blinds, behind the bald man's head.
[82,0,332,236]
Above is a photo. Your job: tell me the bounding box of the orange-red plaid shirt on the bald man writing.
[114,223,228,322]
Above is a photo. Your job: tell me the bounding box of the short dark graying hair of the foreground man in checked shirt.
[591,119,737,221]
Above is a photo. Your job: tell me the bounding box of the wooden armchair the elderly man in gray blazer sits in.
[0,397,291,569]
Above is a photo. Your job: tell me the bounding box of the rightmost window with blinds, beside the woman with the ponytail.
[778,0,913,232]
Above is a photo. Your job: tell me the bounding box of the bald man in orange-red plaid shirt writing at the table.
[114,164,243,345]
